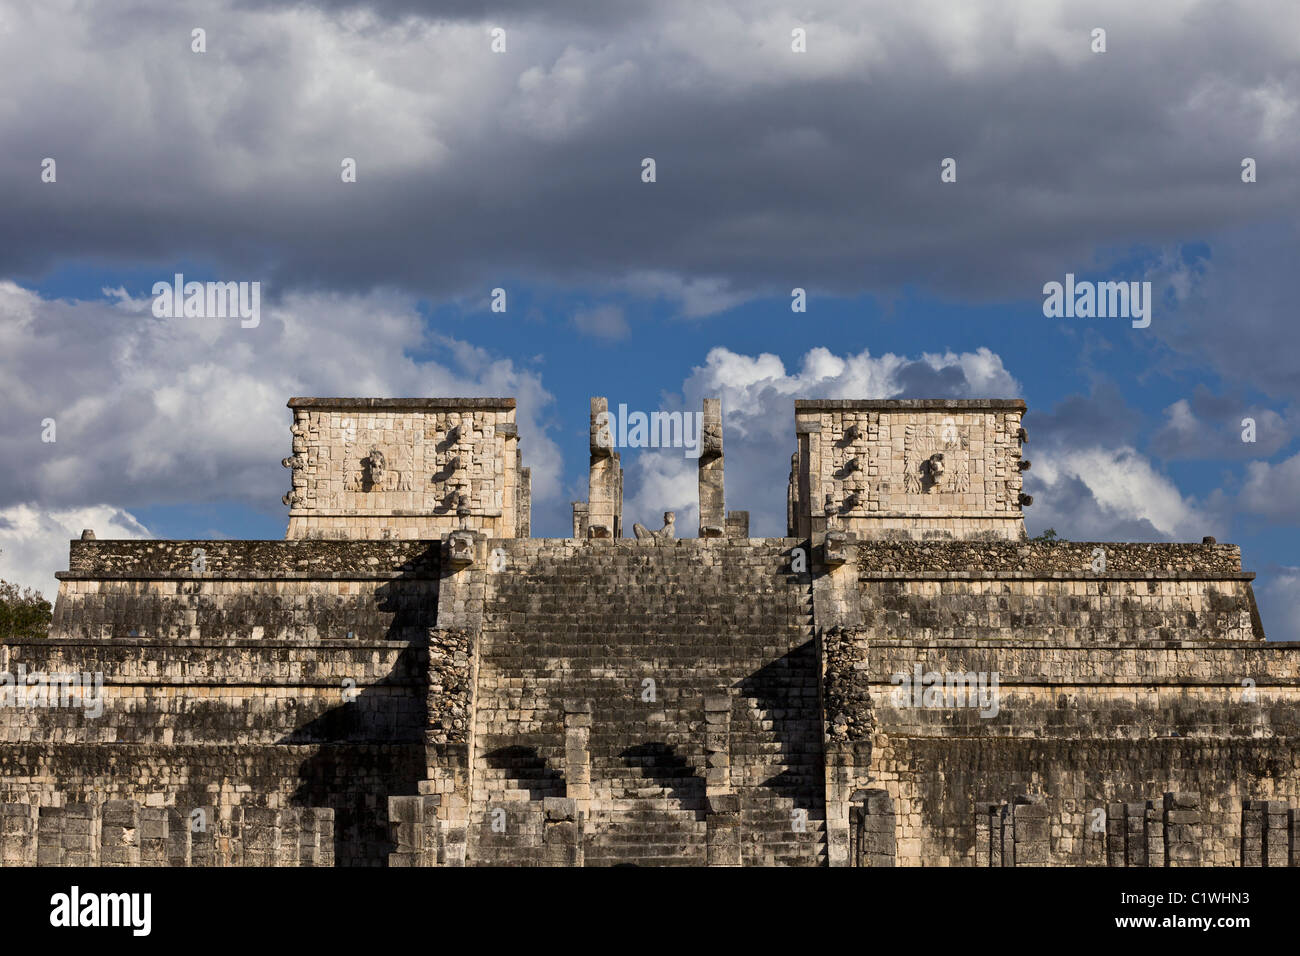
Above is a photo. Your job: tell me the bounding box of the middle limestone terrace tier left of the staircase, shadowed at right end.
[0,639,428,747]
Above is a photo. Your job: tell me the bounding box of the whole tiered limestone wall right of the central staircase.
[820,541,1300,866]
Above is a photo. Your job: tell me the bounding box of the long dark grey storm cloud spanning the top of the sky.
[0,3,1300,335]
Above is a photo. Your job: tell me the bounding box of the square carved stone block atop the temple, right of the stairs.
[788,399,1030,541]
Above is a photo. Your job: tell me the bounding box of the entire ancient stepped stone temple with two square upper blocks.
[0,398,1300,866]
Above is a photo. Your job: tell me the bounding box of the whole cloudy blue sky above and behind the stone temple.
[0,0,1300,639]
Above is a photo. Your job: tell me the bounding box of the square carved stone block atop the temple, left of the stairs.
[282,398,530,538]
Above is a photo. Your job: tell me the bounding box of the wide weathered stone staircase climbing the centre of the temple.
[468,540,826,865]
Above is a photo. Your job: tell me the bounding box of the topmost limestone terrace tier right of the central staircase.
[853,541,1264,644]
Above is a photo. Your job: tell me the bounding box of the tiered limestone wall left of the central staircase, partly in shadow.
[0,540,444,865]
